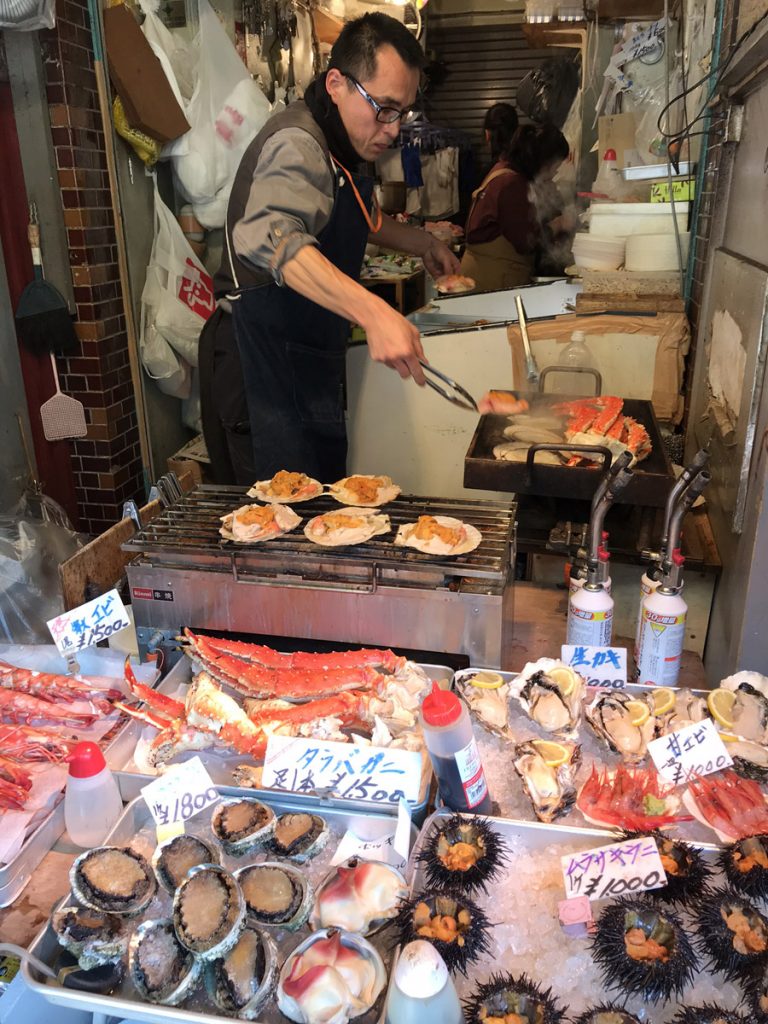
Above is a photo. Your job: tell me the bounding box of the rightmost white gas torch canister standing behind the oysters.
[637,586,688,686]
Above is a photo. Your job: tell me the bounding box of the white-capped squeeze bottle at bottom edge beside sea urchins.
[385,939,464,1024]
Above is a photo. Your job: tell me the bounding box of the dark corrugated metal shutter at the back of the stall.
[426,16,572,180]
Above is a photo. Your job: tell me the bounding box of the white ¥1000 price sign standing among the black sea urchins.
[560,836,667,899]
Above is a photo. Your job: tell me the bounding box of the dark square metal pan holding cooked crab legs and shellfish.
[464,394,674,508]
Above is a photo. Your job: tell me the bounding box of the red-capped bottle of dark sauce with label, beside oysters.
[421,683,492,814]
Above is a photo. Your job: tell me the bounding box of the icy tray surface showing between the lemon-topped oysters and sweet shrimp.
[454,667,713,845]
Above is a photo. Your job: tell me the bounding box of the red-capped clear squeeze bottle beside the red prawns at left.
[65,740,123,850]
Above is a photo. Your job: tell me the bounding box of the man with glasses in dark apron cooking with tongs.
[201,13,459,482]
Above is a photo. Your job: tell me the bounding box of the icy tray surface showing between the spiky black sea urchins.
[411,810,726,1024]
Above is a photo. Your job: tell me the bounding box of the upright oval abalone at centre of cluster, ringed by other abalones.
[173,864,246,961]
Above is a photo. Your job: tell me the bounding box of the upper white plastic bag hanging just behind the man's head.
[163,0,270,228]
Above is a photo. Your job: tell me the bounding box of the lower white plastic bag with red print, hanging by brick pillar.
[140,183,216,398]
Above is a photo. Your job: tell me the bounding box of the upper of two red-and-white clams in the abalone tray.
[310,857,409,935]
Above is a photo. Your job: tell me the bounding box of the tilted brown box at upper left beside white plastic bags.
[103,3,189,142]
